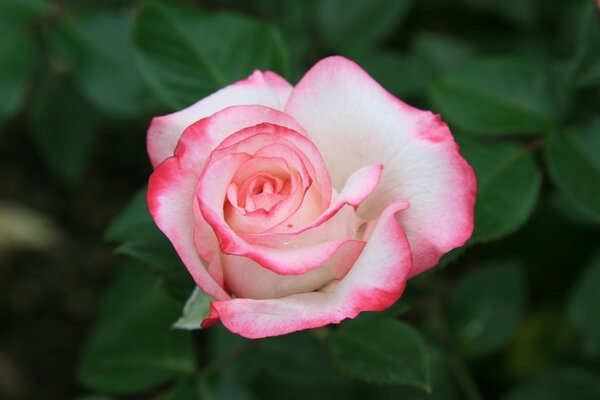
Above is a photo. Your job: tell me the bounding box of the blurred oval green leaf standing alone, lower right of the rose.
[449,261,525,357]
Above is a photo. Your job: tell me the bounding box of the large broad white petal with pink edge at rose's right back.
[285,57,476,275]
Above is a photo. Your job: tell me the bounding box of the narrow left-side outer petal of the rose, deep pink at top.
[147,158,230,300]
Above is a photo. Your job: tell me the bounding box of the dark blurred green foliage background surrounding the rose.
[0,0,600,400]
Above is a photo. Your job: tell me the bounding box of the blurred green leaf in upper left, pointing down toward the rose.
[53,10,147,117]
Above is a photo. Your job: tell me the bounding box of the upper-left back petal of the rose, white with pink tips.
[146,71,292,167]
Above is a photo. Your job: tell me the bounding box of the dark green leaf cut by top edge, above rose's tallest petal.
[317,0,413,48]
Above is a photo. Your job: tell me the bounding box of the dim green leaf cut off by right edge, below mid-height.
[568,253,600,356]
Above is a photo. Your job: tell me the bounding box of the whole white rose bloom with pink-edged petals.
[148,57,476,338]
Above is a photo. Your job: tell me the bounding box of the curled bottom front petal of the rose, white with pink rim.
[202,203,412,339]
